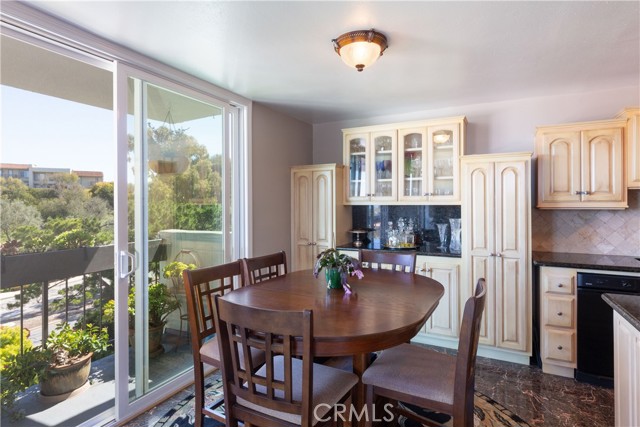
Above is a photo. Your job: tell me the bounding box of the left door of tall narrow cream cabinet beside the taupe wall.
[292,171,314,271]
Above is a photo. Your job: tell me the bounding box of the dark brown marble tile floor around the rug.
[126,357,614,427]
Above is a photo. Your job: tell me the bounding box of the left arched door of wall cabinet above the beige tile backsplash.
[538,132,580,203]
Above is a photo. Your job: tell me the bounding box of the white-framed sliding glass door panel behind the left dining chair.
[116,66,234,418]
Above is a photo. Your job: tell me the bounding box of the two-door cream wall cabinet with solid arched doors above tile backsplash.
[536,120,628,209]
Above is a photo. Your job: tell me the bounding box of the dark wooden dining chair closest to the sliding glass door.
[182,261,264,427]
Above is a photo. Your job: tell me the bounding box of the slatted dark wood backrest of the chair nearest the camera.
[215,297,313,425]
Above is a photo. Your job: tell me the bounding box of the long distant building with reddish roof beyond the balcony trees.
[0,163,104,188]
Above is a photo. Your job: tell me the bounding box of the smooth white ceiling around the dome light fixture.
[18,1,640,123]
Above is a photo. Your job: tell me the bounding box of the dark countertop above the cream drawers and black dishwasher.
[533,252,640,273]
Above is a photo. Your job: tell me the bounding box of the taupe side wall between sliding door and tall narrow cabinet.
[249,103,312,256]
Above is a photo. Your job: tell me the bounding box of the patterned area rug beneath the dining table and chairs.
[154,373,530,427]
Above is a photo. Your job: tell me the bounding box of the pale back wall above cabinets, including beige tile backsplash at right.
[313,87,640,256]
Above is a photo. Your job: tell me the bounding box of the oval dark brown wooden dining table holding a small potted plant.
[223,269,444,424]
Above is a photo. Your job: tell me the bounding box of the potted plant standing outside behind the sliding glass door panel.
[103,282,180,357]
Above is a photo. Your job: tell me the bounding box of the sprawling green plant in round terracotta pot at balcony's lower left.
[1,322,109,418]
